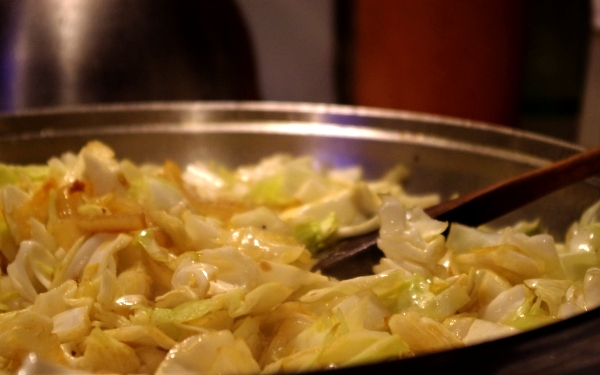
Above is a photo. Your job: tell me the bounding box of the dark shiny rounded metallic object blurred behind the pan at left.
[0,0,258,111]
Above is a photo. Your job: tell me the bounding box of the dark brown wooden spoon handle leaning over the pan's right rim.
[425,146,600,226]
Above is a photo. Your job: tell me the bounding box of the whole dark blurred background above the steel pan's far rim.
[0,0,600,146]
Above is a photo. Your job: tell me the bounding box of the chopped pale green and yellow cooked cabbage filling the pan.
[0,142,600,374]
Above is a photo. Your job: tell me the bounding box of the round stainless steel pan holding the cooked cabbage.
[0,102,600,374]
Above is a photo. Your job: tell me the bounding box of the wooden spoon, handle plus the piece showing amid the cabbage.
[313,146,600,279]
